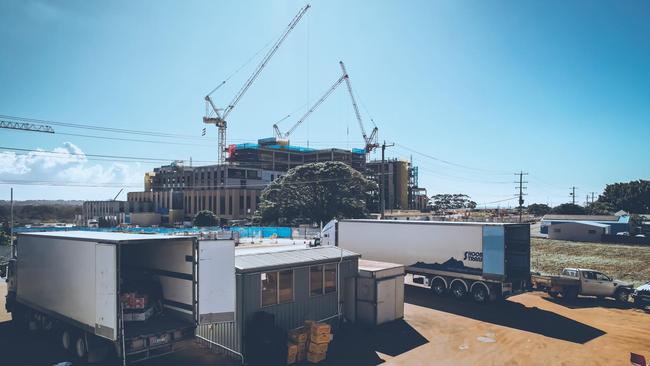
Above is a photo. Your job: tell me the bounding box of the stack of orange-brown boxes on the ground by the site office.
[287,320,332,365]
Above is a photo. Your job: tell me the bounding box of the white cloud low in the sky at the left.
[0,142,145,186]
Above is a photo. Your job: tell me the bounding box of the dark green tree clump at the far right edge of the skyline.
[598,180,650,214]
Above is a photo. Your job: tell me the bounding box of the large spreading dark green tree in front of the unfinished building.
[260,162,377,223]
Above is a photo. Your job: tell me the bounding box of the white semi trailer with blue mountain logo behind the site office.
[320,220,530,302]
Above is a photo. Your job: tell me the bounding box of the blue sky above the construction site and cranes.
[0,0,650,206]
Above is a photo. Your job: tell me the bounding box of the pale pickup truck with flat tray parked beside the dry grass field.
[530,268,634,303]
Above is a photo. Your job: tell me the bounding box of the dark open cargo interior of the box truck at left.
[119,240,195,361]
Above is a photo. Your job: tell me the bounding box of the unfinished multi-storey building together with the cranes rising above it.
[118,5,428,225]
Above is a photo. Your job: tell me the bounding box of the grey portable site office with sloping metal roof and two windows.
[197,247,360,362]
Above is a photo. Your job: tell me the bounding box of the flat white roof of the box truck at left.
[18,231,192,243]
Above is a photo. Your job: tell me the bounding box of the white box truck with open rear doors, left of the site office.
[6,231,235,364]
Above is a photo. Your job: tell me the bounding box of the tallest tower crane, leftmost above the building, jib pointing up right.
[203,4,310,164]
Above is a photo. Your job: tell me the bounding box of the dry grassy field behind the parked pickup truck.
[530,238,650,286]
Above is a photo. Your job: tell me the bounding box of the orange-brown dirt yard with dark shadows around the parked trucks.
[0,282,650,366]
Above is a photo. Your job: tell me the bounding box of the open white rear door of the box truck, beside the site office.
[196,240,235,324]
